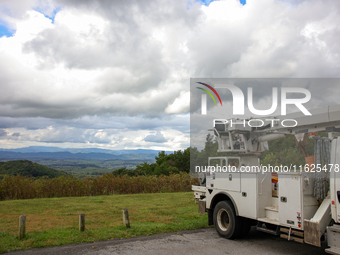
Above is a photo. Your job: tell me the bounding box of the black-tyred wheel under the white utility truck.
[213,201,242,239]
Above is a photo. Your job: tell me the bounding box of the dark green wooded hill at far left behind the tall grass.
[0,160,71,178]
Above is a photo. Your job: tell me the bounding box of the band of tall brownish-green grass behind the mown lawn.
[0,173,198,200]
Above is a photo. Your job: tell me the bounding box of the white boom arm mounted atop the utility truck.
[212,105,340,155]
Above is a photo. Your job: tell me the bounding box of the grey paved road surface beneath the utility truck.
[7,228,326,255]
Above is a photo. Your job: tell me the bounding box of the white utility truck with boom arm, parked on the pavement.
[192,105,340,254]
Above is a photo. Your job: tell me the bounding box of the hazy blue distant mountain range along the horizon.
[0,146,172,160]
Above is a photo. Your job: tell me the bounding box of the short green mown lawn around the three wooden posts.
[0,192,208,253]
